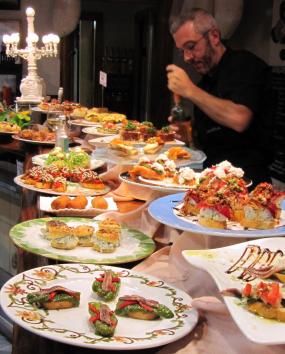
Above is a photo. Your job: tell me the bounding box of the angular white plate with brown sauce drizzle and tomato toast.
[182,237,285,344]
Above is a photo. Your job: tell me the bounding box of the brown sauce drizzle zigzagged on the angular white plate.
[226,245,284,281]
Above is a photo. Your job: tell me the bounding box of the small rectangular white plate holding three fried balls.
[40,196,118,216]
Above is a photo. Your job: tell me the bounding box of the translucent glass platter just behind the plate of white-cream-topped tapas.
[89,147,206,168]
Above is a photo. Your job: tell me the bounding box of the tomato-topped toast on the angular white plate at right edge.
[222,281,285,322]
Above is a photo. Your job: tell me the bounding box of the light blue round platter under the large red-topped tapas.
[148,193,285,238]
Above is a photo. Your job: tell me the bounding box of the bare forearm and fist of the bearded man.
[166,64,252,132]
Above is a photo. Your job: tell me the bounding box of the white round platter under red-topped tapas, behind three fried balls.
[14,175,111,196]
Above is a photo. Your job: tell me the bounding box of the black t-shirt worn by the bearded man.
[193,49,271,184]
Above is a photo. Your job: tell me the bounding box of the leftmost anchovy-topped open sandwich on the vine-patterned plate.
[27,285,80,310]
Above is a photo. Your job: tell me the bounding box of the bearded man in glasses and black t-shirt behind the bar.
[166,8,272,185]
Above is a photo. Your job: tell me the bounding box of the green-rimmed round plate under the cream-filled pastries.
[10,217,155,264]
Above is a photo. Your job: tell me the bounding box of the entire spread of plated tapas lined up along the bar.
[0,100,285,350]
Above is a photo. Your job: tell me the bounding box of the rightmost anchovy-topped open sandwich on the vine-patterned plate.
[115,295,174,320]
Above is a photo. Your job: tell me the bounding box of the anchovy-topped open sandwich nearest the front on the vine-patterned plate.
[88,302,118,337]
